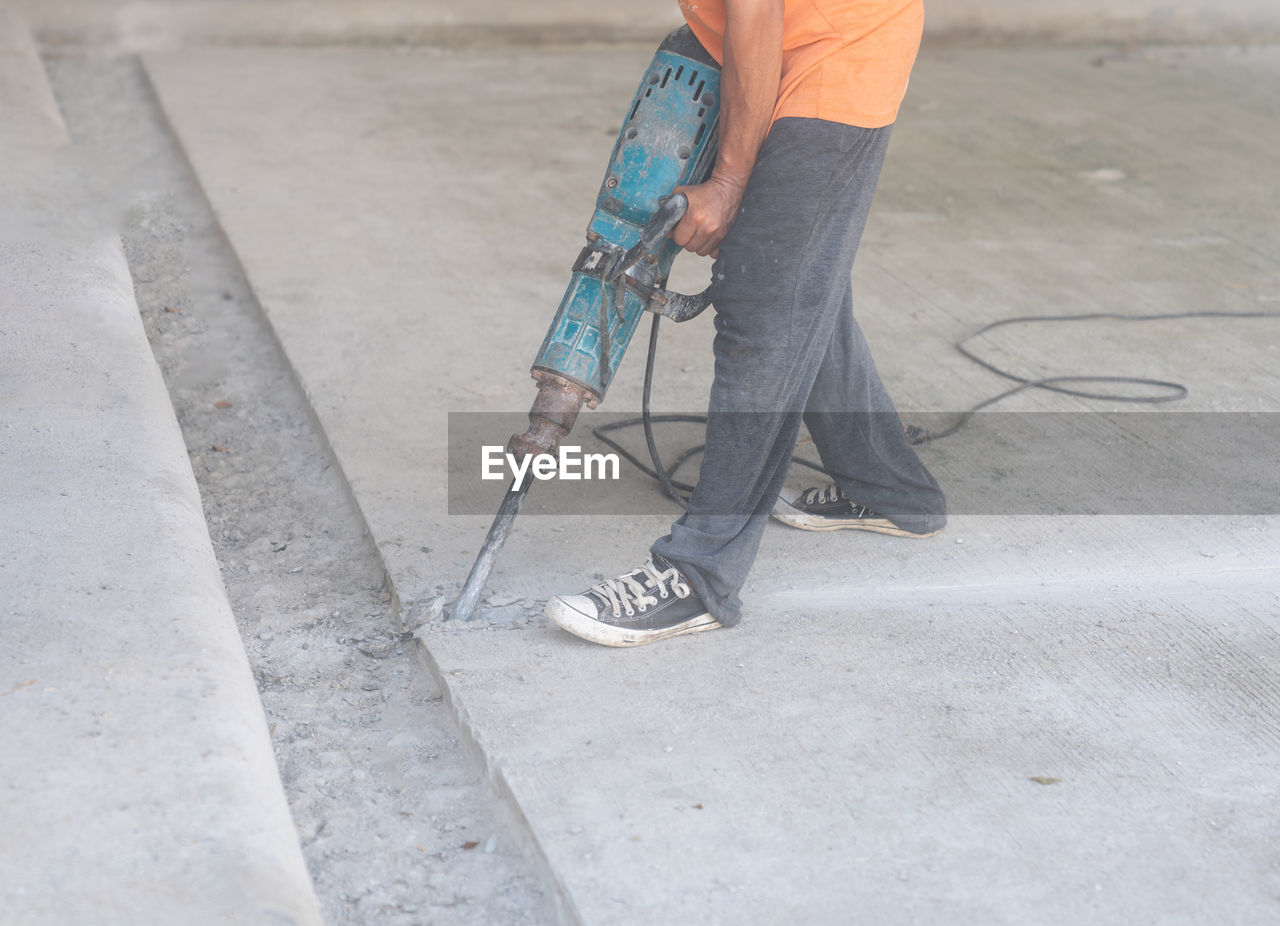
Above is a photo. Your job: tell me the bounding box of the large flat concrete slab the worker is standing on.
[146,38,1280,923]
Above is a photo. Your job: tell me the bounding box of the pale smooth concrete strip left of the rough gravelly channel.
[0,10,319,923]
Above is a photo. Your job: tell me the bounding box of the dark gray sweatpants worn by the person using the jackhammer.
[652,113,946,625]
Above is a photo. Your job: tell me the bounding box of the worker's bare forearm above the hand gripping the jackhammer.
[712,0,783,190]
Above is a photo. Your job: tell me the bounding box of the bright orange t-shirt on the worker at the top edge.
[680,0,924,128]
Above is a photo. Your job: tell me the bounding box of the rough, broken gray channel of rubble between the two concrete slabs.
[46,55,554,925]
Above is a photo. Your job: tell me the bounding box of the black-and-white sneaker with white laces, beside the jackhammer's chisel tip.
[544,556,721,647]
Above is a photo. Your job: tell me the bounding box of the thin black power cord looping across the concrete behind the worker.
[591,311,1280,508]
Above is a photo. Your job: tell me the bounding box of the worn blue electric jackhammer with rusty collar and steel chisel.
[449,26,721,620]
